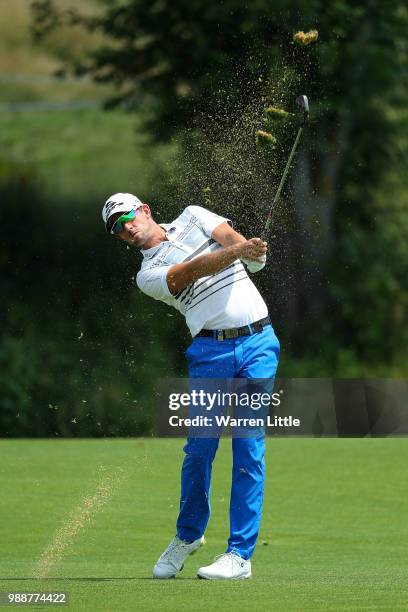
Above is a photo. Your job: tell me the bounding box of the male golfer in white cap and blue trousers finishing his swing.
[102,193,279,580]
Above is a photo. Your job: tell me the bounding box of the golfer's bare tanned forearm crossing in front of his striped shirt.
[167,244,241,294]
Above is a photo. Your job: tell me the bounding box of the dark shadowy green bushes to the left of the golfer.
[0,164,188,437]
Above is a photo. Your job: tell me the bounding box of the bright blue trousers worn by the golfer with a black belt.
[177,325,279,559]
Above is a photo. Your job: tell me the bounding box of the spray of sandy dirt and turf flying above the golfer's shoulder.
[169,32,316,243]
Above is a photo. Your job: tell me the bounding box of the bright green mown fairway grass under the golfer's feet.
[0,438,408,611]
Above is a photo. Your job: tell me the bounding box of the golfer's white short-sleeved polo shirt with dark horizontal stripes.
[136,206,268,336]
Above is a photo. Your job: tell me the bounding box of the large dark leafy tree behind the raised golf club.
[33,0,408,368]
